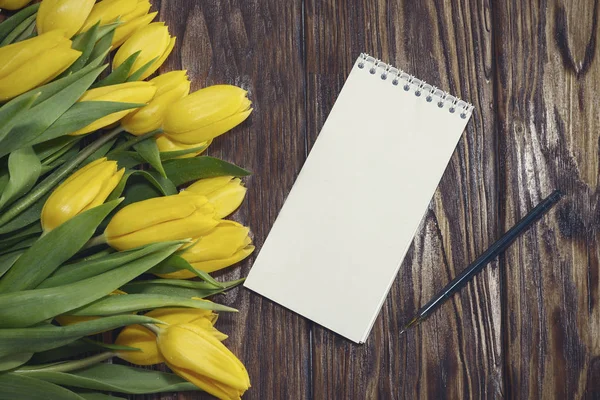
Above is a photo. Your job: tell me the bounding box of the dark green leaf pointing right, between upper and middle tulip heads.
[163,156,250,186]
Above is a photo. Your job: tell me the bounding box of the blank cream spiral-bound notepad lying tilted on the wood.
[245,54,473,343]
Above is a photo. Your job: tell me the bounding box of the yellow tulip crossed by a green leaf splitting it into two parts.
[71,82,156,136]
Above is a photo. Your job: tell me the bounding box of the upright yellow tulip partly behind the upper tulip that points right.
[121,71,190,136]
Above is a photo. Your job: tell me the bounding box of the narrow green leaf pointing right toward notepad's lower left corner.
[121,279,244,298]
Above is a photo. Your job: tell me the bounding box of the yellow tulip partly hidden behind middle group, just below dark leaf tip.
[181,176,247,218]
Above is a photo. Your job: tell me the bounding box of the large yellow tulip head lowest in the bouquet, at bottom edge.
[157,324,250,400]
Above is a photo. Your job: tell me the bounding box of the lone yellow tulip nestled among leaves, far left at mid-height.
[41,158,125,232]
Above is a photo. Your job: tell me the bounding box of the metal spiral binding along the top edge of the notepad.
[358,53,473,119]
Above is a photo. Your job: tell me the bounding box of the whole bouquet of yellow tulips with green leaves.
[0,0,254,399]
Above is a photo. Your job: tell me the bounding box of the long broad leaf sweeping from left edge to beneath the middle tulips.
[0,242,182,328]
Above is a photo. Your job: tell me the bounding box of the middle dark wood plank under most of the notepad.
[306,0,503,399]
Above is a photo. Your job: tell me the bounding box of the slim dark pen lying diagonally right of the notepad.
[400,190,562,334]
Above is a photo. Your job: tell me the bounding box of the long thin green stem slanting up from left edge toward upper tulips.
[0,126,123,226]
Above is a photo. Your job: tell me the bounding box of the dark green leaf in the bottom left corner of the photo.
[0,372,85,400]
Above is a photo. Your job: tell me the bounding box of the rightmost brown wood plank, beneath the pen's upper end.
[494,0,600,399]
